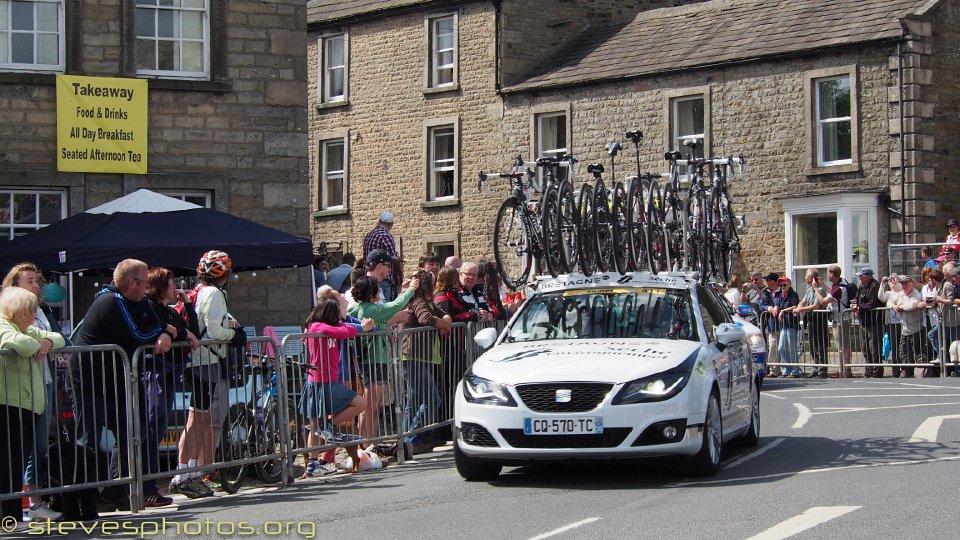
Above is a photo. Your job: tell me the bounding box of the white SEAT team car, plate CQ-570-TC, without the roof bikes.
[454,272,760,480]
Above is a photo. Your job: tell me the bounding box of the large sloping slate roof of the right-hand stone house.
[504,0,931,92]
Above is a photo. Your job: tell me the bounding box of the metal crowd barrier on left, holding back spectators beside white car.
[0,321,505,512]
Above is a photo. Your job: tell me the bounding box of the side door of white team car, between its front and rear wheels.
[699,286,750,427]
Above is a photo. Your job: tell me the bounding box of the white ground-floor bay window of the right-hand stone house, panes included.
[783,193,878,296]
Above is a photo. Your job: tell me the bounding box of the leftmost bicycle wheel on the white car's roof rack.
[493,197,533,291]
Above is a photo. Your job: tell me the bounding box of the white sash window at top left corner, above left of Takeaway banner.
[0,0,64,72]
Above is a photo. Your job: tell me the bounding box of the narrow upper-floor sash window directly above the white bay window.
[815,76,853,167]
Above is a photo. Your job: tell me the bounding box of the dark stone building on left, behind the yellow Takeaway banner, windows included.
[0,0,311,326]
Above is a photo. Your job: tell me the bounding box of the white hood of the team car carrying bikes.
[473,338,701,385]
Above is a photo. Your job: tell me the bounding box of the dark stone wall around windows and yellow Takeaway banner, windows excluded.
[0,0,311,327]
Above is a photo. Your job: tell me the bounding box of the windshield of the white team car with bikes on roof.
[507,287,699,342]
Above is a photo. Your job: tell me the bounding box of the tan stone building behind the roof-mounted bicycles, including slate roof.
[308,0,960,286]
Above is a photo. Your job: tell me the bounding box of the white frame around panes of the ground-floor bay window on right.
[783,193,880,292]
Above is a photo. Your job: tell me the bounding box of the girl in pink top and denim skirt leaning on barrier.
[300,298,373,476]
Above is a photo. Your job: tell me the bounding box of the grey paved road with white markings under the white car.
[9,379,960,539]
